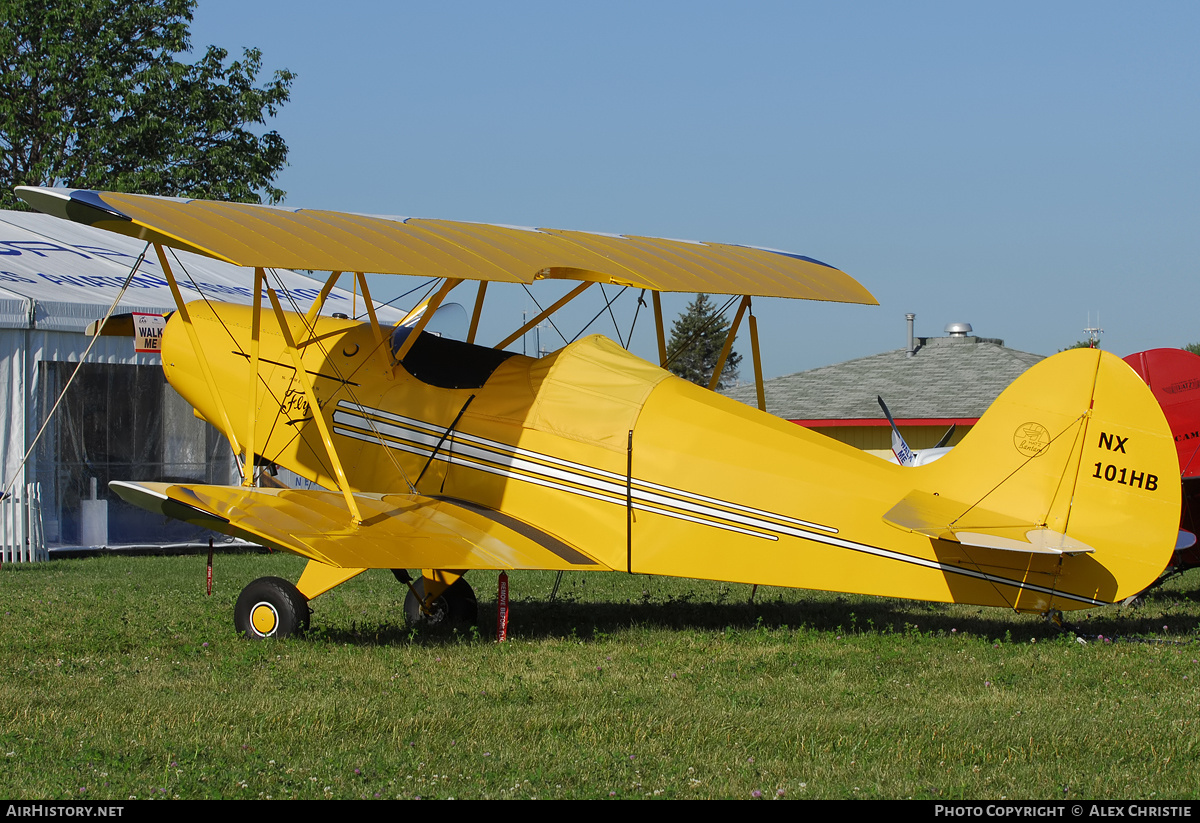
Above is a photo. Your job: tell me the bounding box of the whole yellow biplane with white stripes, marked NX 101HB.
[17,187,1180,637]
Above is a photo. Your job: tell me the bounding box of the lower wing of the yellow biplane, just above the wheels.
[112,482,608,571]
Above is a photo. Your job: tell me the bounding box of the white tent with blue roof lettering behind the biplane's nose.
[0,211,402,545]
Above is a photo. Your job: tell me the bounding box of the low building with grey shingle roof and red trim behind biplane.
[725,324,1043,449]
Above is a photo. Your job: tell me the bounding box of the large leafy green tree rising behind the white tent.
[0,0,295,209]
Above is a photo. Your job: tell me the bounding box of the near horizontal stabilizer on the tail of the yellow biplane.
[883,491,1093,554]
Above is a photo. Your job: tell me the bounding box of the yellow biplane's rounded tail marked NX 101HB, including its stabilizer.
[886,349,1180,608]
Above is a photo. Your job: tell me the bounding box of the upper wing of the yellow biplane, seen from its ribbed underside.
[16,186,878,305]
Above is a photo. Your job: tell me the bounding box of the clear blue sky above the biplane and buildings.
[192,0,1200,378]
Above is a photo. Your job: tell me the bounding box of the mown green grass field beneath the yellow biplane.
[0,555,1200,800]
